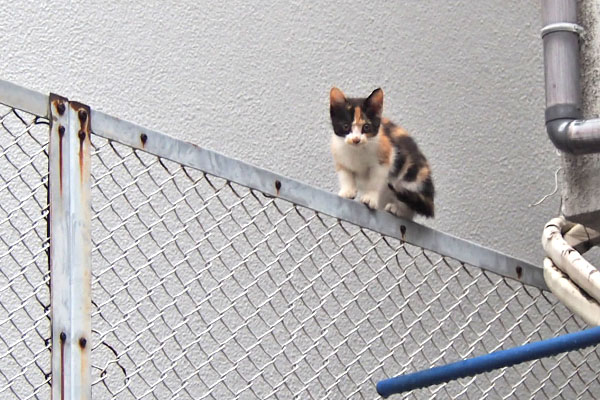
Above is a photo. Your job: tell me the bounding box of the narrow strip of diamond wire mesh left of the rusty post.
[0,105,50,399]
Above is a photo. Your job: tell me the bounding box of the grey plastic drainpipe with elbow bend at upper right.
[542,0,600,154]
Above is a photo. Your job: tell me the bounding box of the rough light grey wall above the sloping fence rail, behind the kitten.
[0,0,559,264]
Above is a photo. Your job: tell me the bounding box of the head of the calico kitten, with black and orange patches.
[329,87,383,145]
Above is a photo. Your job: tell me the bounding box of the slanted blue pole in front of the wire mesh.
[377,326,600,397]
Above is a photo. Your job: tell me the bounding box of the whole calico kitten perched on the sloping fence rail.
[329,87,435,219]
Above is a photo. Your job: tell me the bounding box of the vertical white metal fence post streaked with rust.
[48,94,91,400]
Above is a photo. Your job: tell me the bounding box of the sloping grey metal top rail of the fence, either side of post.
[0,79,548,290]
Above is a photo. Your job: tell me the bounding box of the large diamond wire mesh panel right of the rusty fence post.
[92,136,600,399]
